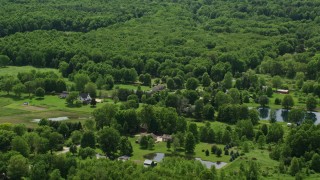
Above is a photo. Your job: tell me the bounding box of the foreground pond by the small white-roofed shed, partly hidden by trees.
[143,153,227,169]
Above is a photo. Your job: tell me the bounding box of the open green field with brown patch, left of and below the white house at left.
[0,93,104,127]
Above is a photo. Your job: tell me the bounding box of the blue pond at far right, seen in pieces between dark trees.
[258,108,320,125]
